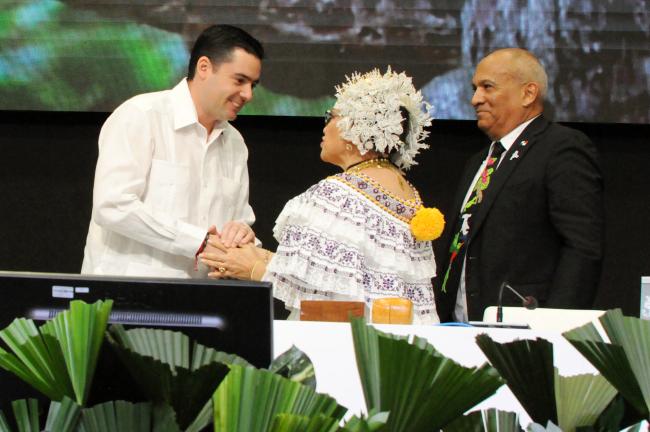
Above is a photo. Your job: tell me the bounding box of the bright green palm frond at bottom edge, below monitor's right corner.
[212,365,346,432]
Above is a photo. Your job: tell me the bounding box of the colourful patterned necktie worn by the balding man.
[442,141,505,292]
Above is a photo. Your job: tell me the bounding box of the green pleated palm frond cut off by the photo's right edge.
[563,309,650,418]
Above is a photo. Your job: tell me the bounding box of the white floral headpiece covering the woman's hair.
[334,66,431,169]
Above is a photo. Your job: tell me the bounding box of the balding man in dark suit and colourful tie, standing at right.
[436,48,604,321]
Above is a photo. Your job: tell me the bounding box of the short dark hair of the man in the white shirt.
[187,24,264,80]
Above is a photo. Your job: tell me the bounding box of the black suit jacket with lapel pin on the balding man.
[434,116,604,321]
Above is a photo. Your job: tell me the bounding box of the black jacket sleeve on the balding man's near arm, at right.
[546,131,604,308]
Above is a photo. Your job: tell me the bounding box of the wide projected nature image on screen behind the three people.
[0,0,650,123]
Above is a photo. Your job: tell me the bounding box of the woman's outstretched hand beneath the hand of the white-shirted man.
[199,243,269,280]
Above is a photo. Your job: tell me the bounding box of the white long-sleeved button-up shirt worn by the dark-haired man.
[81,79,255,278]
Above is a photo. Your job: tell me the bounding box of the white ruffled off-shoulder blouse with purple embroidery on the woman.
[264,173,439,323]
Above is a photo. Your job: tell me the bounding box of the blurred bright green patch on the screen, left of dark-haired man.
[0,0,188,111]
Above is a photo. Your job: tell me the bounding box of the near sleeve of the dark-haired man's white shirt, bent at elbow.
[92,104,205,257]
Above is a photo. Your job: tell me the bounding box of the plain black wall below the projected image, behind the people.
[0,111,650,315]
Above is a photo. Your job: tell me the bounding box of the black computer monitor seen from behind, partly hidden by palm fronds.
[0,272,273,409]
